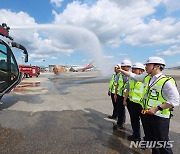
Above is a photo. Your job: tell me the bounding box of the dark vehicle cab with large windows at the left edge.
[0,23,28,98]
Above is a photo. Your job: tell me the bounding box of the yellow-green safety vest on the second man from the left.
[117,74,127,96]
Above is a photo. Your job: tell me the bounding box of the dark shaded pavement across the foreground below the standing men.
[0,107,180,154]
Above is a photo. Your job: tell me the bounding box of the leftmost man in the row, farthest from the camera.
[108,64,121,119]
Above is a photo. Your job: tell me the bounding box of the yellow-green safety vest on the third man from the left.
[129,79,144,105]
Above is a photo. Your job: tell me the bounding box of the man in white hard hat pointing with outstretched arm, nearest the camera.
[116,57,180,154]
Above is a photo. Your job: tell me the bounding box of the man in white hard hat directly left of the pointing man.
[123,63,145,141]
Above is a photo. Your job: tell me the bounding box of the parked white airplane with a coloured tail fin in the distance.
[69,61,94,72]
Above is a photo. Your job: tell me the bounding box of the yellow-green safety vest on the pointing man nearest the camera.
[142,75,176,118]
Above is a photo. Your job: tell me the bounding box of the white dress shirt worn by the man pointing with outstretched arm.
[130,72,180,106]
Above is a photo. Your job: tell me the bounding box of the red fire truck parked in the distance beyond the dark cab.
[19,65,40,78]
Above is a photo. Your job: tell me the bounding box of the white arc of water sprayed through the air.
[11,24,109,75]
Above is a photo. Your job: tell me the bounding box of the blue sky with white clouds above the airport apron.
[0,0,180,68]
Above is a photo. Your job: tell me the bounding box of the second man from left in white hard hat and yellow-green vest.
[114,59,131,130]
